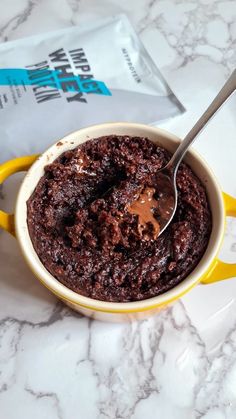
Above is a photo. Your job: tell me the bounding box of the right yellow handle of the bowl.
[201,192,236,284]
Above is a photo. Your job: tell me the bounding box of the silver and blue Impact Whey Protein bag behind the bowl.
[0,15,184,161]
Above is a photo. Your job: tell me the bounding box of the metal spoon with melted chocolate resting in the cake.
[155,70,236,235]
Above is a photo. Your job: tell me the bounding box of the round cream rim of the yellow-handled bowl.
[15,122,225,313]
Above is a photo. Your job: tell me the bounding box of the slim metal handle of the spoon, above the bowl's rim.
[166,70,236,176]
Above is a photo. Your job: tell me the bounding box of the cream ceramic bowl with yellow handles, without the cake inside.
[0,123,236,321]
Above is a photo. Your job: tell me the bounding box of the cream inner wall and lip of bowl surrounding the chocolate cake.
[15,122,224,312]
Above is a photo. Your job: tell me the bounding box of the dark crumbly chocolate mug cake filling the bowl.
[27,135,211,302]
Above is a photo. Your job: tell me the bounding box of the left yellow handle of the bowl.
[0,154,38,236]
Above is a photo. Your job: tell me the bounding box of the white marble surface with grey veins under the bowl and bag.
[0,0,236,419]
